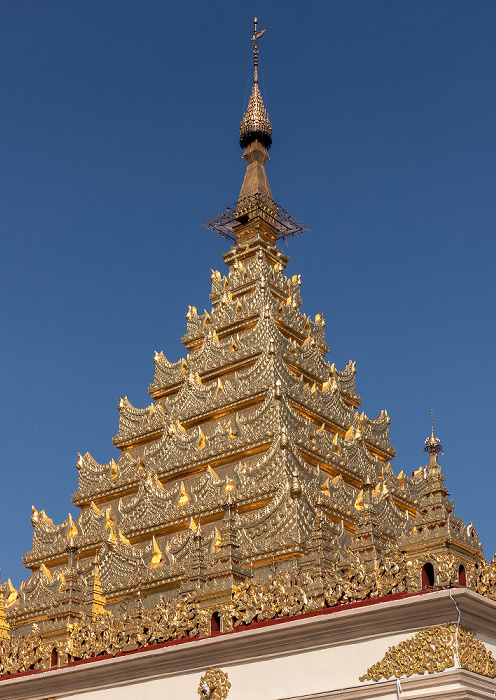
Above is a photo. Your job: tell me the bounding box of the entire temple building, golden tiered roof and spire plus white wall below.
[0,22,496,700]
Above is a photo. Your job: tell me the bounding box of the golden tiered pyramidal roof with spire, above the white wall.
[0,20,495,675]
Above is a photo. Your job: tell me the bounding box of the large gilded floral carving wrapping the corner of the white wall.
[360,624,496,681]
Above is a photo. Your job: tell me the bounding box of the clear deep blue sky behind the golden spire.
[0,0,496,585]
